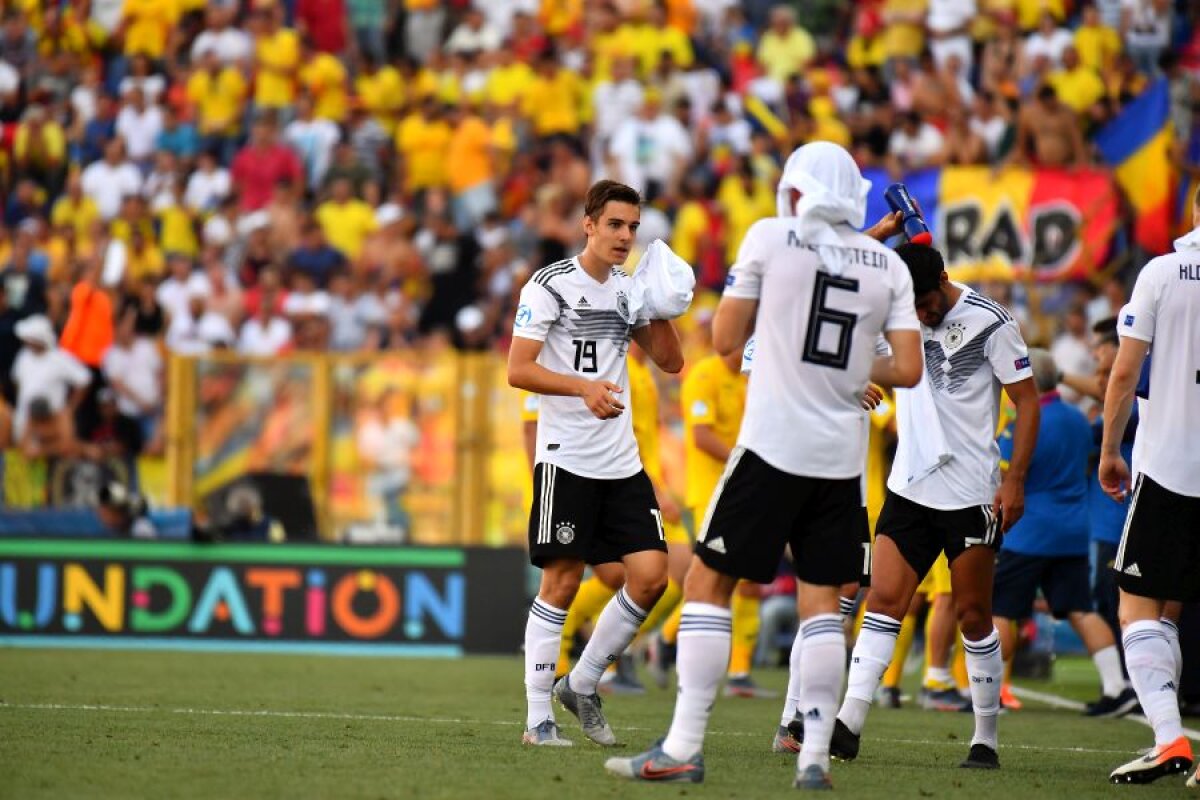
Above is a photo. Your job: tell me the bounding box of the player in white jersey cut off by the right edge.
[1099,189,1200,788]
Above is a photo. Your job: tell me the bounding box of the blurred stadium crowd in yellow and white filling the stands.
[0,0,1200,470]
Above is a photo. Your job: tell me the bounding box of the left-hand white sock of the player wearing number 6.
[662,602,733,762]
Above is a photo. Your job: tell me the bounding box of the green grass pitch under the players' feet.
[0,649,1188,800]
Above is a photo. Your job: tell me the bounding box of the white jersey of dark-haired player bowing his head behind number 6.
[888,283,1033,510]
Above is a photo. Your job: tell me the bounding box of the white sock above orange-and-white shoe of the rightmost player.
[1121,619,1183,746]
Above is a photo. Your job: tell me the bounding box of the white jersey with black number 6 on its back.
[725,217,919,479]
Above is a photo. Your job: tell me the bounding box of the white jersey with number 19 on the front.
[512,258,649,479]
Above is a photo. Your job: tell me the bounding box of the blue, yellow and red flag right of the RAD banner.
[1096,79,1175,255]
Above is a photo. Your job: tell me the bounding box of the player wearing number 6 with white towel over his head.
[606,142,920,788]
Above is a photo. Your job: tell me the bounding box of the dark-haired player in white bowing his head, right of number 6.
[832,243,1039,769]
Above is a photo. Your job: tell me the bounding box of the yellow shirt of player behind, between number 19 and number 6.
[680,354,748,506]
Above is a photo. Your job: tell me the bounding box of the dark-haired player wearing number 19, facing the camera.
[509,181,683,746]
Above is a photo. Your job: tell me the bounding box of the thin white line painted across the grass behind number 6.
[0,700,1128,754]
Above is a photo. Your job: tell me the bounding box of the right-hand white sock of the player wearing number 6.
[797,614,844,770]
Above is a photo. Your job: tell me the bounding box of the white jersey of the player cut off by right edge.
[1117,249,1200,498]
